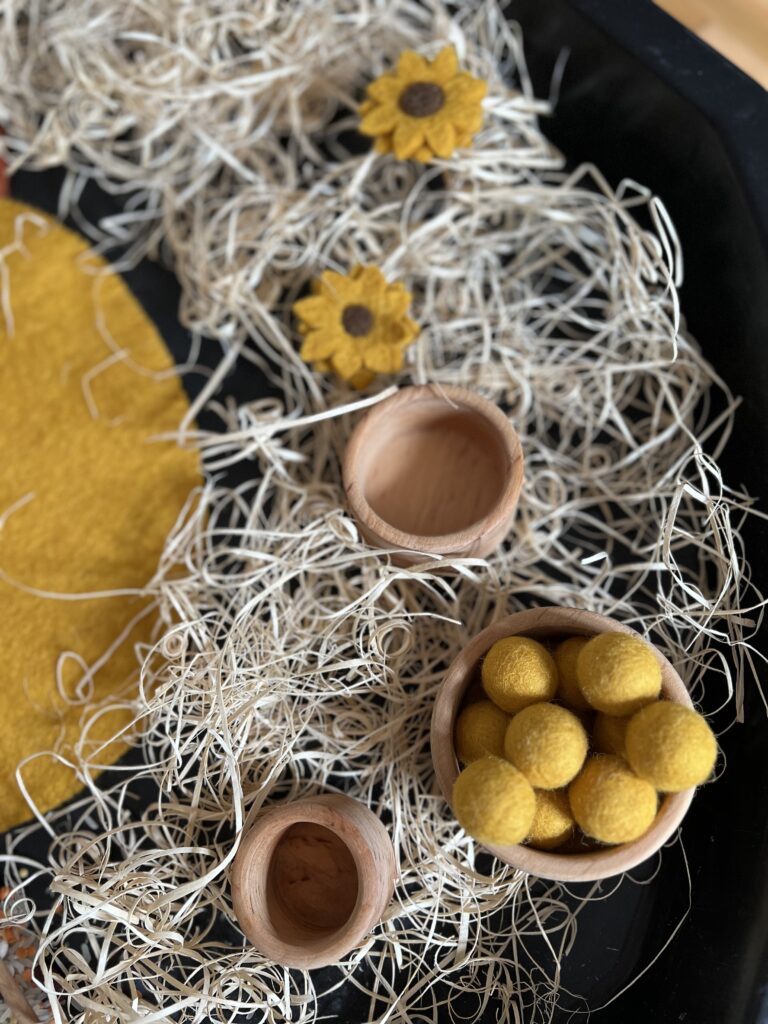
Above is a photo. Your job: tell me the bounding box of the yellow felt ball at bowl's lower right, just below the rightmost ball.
[568,754,656,843]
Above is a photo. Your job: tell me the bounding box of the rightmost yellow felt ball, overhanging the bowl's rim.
[627,700,718,793]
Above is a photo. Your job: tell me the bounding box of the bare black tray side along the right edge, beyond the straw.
[510,0,768,1024]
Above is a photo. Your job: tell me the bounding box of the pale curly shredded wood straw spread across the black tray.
[0,0,763,1024]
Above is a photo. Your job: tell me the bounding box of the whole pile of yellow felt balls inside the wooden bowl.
[453,633,717,852]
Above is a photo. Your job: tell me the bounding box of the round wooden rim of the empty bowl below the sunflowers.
[342,384,524,554]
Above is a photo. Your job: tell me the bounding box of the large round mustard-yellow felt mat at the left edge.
[0,200,200,830]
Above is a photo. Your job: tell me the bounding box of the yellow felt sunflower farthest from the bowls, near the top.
[359,46,487,163]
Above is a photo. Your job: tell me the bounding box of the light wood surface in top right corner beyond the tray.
[656,0,768,87]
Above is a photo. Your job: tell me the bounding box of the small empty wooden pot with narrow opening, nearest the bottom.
[232,794,396,970]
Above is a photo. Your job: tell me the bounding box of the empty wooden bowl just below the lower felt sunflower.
[343,384,523,565]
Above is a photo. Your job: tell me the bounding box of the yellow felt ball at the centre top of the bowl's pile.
[504,703,588,790]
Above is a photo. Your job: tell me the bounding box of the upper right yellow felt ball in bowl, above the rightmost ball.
[577,633,662,715]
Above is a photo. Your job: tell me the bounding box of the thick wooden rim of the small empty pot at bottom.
[231,793,396,970]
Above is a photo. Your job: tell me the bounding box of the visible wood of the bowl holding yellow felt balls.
[431,607,695,882]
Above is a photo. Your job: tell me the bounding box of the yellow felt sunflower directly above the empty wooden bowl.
[293,266,419,388]
